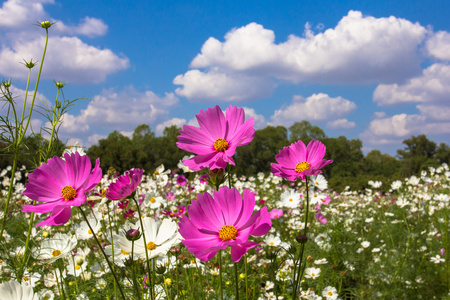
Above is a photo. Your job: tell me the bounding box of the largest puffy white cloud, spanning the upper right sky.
[174,11,427,100]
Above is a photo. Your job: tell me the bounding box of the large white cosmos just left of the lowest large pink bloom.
[134,217,181,259]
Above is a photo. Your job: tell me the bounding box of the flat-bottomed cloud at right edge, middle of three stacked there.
[373,63,450,105]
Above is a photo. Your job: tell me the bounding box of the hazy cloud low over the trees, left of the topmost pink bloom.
[60,87,179,142]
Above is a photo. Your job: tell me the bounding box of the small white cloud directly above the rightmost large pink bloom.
[271,93,356,128]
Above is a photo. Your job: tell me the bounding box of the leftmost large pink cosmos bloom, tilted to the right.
[22,152,102,226]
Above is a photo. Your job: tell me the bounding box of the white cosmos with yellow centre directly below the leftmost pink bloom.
[35,232,77,263]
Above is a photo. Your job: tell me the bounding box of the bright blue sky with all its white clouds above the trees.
[0,0,450,155]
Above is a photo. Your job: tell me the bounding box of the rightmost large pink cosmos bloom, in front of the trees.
[270,141,333,181]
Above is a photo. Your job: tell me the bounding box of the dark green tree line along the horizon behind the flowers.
[0,121,450,192]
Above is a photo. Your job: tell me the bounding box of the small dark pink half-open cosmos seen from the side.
[106,169,144,200]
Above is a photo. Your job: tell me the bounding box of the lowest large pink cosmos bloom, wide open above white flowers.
[179,187,272,262]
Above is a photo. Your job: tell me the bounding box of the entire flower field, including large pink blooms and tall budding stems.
[0,21,450,300]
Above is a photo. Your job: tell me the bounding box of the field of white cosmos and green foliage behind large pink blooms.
[0,155,450,299]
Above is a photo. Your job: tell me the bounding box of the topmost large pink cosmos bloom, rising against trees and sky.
[177,105,255,171]
